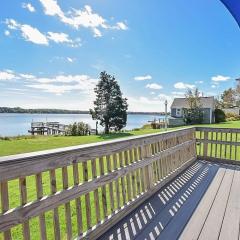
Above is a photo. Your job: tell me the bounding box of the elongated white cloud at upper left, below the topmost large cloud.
[5,19,81,47]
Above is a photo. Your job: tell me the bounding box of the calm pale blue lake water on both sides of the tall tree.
[0,113,163,136]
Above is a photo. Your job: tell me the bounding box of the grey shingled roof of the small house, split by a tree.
[171,97,215,108]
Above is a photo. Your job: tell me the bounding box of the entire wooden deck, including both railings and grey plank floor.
[0,127,240,240]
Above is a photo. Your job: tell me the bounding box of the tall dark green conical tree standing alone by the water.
[90,72,128,134]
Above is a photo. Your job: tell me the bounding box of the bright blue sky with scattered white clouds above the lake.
[0,0,240,111]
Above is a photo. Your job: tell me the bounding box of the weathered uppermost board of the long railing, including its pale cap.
[0,128,192,181]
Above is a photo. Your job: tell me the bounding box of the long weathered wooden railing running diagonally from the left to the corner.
[0,128,196,240]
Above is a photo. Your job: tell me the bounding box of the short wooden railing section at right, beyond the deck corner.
[196,127,240,163]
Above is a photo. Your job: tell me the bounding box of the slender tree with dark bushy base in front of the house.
[183,88,203,124]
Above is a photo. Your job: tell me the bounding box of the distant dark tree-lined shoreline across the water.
[0,107,165,115]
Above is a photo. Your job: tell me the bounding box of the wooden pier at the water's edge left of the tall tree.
[28,122,66,135]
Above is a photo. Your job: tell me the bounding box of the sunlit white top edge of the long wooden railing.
[0,127,195,163]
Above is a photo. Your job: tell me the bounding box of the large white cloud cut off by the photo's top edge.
[40,0,128,37]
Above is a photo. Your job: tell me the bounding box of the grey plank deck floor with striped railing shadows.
[99,161,240,240]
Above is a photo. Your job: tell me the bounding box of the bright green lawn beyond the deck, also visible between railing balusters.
[0,121,240,240]
